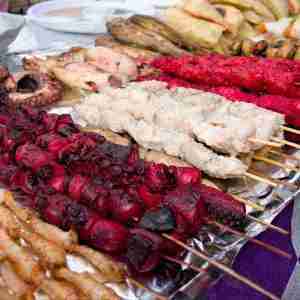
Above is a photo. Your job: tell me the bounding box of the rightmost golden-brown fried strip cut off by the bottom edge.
[55,268,120,300]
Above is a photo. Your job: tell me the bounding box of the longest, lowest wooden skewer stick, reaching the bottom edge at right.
[162,233,280,300]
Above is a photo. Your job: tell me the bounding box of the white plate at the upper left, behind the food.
[27,0,155,34]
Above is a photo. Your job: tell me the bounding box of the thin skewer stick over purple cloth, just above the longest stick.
[207,220,292,259]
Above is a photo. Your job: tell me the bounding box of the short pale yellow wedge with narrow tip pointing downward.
[215,4,245,36]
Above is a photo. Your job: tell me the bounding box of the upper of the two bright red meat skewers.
[152,55,300,98]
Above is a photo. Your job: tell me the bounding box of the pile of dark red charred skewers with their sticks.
[0,79,296,299]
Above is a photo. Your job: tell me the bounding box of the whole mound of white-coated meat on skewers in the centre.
[76,81,284,178]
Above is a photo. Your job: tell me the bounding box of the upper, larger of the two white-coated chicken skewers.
[76,81,284,155]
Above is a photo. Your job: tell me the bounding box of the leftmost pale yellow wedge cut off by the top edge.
[183,0,228,28]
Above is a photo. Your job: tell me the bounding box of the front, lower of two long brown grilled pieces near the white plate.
[106,18,186,56]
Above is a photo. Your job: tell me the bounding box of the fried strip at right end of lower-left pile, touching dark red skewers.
[70,245,126,282]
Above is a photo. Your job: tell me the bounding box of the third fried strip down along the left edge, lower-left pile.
[0,228,44,285]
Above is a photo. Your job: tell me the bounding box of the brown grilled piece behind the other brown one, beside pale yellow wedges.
[129,15,183,47]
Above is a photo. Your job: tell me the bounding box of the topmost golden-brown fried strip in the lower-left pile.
[4,192,78,248]
